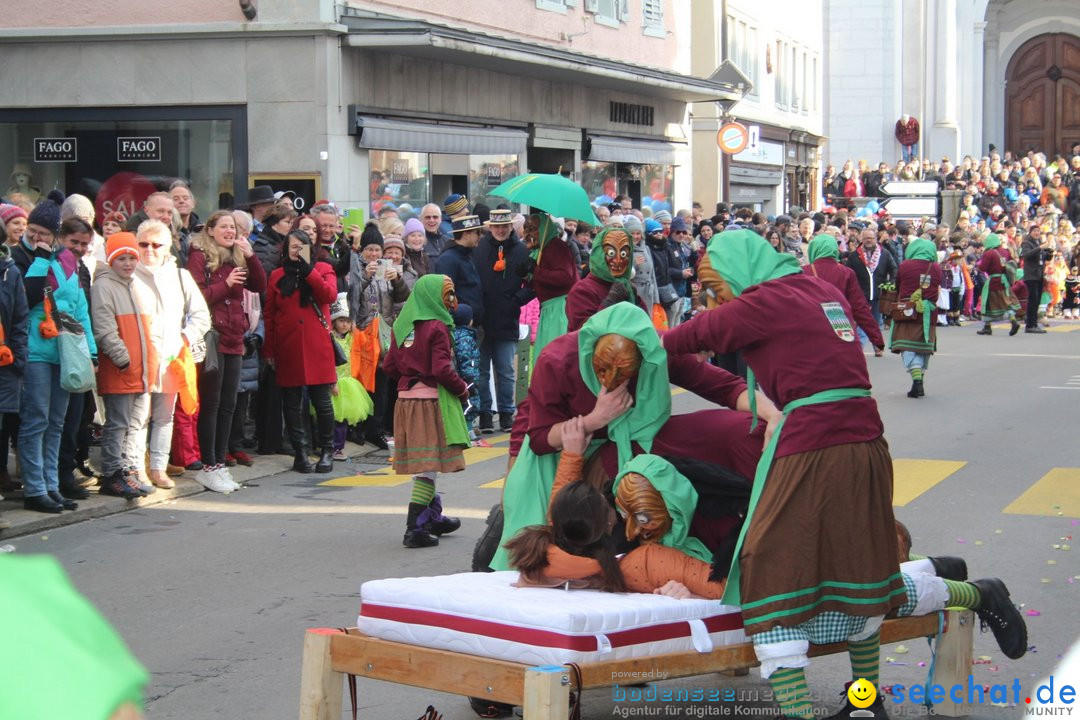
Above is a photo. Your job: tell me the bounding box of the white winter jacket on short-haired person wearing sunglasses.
[132,257,210,393]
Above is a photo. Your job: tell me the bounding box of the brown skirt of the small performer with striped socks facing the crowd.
[394,397,465,475]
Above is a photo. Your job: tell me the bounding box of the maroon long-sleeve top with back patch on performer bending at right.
[663,274,883,458]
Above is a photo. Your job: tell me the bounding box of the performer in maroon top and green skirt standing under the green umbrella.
[523,212,578,377]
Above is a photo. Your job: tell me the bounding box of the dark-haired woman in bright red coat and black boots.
[262,230,337,473]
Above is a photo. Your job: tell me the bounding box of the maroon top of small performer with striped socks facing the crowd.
[382,320,469,397]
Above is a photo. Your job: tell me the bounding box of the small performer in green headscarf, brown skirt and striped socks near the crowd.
[382,275,469,547]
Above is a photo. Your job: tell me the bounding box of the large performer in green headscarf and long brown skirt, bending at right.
[663,230,905,718]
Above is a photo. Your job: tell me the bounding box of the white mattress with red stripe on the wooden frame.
[356,571,746,665]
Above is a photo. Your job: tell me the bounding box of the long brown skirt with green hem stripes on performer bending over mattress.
[739,437,905,635]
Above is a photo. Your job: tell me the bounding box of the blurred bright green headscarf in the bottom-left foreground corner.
[0,555,150,720]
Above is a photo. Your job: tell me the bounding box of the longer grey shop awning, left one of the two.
[355,116,529,157]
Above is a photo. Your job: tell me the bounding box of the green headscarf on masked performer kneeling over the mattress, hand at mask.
[578,302,672,467]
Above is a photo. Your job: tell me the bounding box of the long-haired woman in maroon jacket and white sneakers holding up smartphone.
[188,210,267,488]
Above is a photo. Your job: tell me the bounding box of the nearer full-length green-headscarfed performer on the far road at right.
[889,239,942,397]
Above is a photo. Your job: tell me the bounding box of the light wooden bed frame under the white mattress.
[300,610,974,720]
